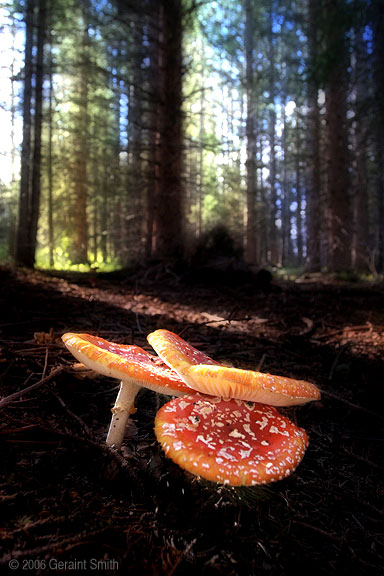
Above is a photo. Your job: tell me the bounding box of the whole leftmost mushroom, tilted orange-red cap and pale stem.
[62,332,190,448]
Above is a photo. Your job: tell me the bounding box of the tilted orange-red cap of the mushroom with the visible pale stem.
[62,332,190,395]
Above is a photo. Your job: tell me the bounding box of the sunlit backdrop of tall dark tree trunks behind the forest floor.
[0,0,384,276]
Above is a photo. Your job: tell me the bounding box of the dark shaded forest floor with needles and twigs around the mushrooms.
[0,267,384,576]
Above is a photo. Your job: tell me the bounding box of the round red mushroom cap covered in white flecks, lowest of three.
[155,394,308,486]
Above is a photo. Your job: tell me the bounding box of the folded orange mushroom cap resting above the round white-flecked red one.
[147,330,320,406]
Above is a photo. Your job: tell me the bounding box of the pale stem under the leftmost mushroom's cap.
[107,380,141,449]
